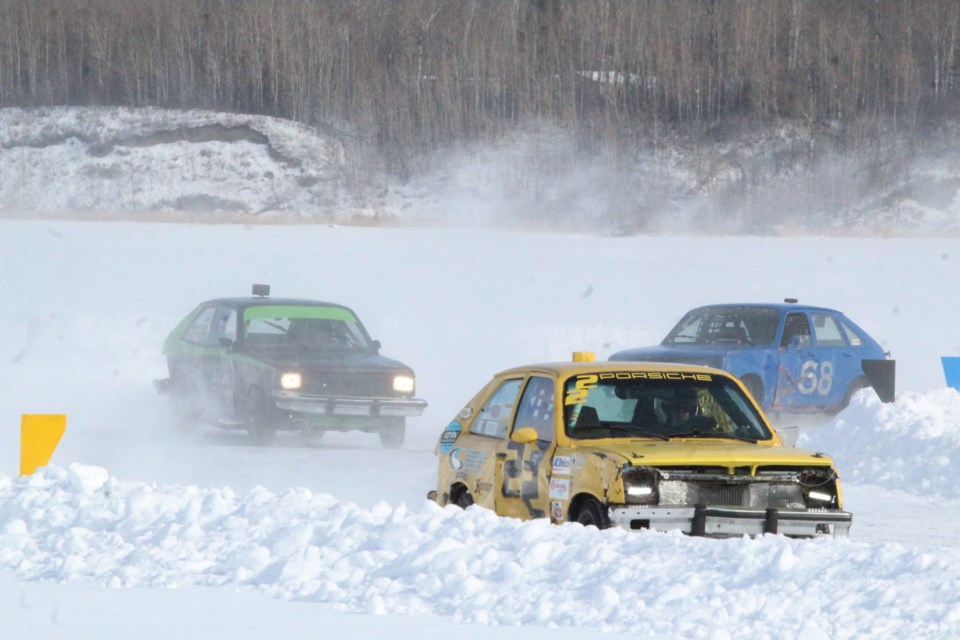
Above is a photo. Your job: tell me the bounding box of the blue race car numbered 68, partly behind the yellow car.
[610,298,896,413]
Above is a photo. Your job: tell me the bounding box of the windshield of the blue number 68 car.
[662,306,780,345]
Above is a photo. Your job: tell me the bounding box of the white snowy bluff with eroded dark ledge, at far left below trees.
[0,107,349,221]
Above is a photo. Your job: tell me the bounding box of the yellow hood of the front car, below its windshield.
[578,439,833,467]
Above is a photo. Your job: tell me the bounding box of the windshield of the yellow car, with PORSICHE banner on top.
[564,371,772,442]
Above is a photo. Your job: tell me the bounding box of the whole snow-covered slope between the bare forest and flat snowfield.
[0,107,960,237]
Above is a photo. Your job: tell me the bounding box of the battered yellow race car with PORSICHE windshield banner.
[429,352,852,537]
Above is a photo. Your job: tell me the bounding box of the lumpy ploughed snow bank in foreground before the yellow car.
[0,465,960,638]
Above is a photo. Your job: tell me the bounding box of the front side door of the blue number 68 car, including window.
[773,311,820,409]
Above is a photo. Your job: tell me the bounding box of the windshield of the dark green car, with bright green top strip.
[243,305,373,351]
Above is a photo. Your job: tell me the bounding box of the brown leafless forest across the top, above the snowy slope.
[0,0,960,173]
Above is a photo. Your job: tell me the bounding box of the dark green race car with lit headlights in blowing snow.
[154,285,427,449]
